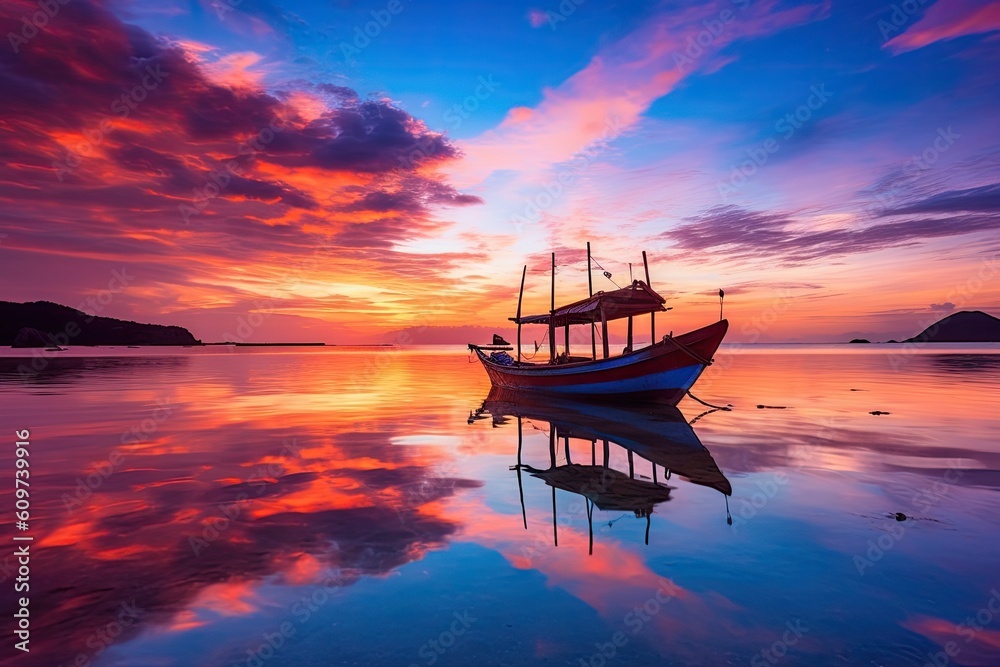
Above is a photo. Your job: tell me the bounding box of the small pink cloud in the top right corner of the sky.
[886,0,1000,53]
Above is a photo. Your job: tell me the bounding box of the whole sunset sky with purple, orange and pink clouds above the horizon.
[0,0,1000,343]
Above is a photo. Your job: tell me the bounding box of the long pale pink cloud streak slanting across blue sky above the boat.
[455,0,826,182]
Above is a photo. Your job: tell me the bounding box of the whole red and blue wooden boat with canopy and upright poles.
[469,244,729,403]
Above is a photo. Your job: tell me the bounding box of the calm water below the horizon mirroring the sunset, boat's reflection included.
[0,346,1000,667]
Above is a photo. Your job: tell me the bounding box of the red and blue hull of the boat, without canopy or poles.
[475,320,729,404]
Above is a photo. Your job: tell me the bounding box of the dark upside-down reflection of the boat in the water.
[469,387,733,554]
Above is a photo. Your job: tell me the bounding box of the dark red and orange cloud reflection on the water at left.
[0,357,480,666]
